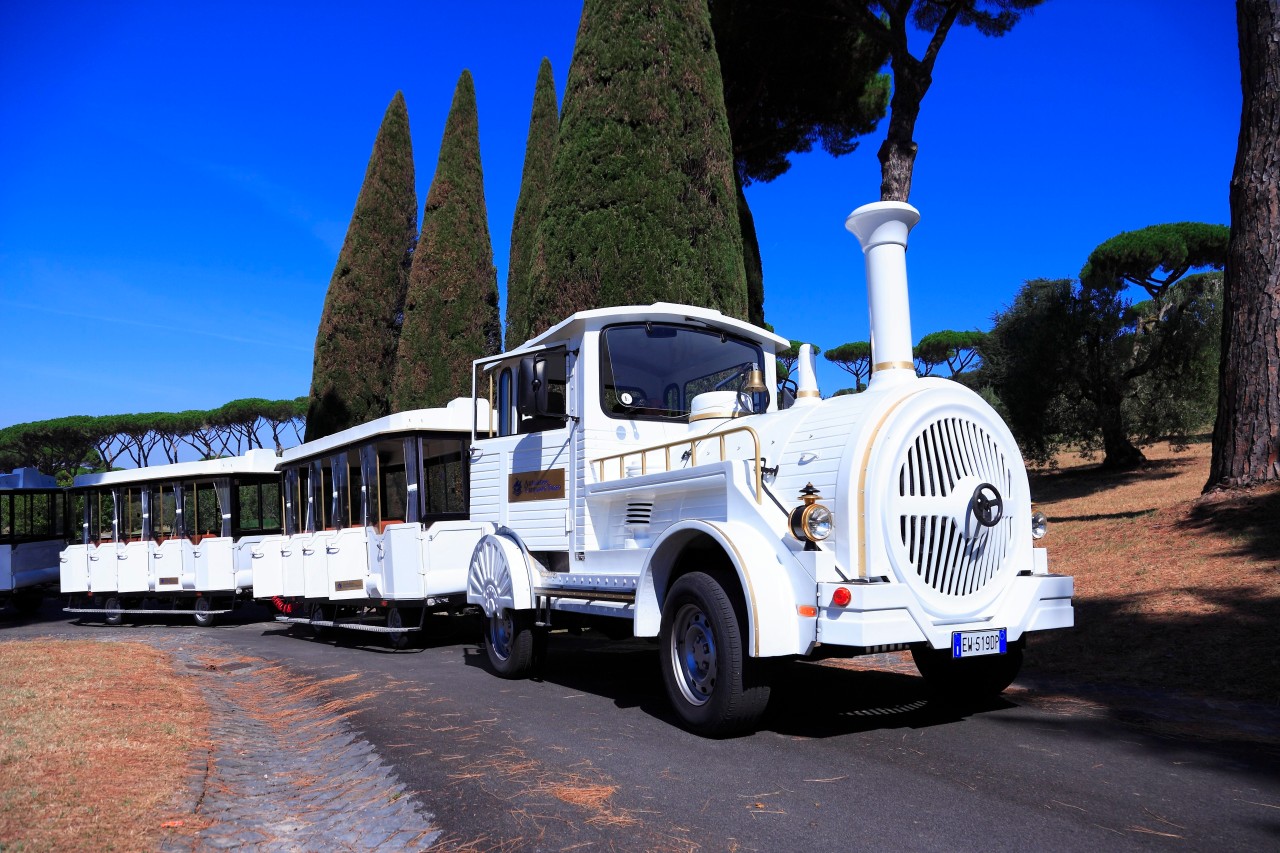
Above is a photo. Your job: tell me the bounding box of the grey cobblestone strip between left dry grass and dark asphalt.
[129,631,439,853]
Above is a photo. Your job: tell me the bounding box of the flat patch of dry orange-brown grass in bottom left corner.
[0,640,209,850]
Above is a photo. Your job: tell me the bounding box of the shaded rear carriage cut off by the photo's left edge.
[0,467,67,612]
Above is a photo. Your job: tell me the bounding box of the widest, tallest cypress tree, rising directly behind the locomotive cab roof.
[531,0,748,328]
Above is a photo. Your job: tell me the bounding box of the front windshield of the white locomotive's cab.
[600,323,769,420]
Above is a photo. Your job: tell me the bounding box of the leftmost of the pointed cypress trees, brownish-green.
[306,92,417,442]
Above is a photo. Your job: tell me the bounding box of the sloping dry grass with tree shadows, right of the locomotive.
[1029,435,1280,703]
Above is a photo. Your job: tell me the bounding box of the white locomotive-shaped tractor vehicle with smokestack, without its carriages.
[467,202,1074,734]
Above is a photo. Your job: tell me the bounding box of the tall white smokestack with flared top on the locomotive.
[845,201,920,384]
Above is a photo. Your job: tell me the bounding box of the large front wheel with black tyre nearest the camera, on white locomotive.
[659,573,769,735]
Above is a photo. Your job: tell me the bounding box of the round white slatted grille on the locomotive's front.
[896,418,1014,597]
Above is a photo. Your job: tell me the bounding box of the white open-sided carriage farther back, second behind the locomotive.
[59,450,282,626]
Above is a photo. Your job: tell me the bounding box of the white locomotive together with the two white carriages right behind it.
[42,202,1074,734]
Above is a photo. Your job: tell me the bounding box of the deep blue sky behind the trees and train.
[0,0,1240,427]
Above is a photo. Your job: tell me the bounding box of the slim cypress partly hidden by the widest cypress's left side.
[507,56,559,345]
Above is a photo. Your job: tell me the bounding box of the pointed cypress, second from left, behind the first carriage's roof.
[392,70,502,411]
